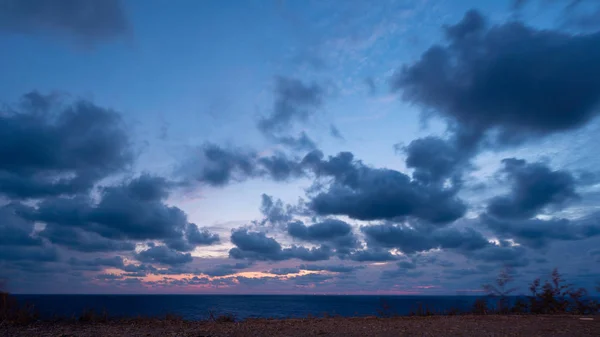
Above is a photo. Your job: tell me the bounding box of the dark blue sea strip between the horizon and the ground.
[17,295,502,320]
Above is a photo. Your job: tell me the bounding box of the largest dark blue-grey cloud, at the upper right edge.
[392,10,600,149]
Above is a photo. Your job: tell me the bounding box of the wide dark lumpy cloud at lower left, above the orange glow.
[28,174,219,252]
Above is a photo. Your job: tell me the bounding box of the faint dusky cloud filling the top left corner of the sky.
[0,0,129,42]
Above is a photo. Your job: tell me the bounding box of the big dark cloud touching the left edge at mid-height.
[0,92,132,199]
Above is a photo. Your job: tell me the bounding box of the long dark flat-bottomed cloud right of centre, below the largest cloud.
[303,152,466,223]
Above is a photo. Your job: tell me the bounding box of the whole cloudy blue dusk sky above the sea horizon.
[0,0,600,295]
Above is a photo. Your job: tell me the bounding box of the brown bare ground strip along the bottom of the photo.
[0,316,600,337]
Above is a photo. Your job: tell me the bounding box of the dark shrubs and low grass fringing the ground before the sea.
[0,269,600,325]
